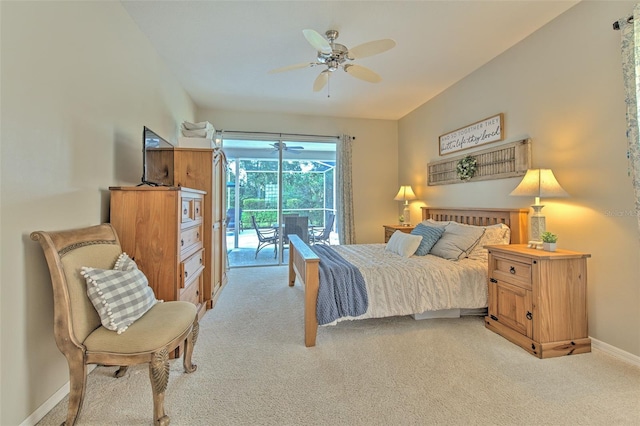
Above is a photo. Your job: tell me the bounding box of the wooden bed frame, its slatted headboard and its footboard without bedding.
[289,207,529,347]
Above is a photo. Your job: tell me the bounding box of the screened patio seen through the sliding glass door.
[222,133,338,267]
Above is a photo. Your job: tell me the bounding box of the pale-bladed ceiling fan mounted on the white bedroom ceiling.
[269,30,396,92]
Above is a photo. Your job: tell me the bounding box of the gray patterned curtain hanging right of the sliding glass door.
[336,135,356,244]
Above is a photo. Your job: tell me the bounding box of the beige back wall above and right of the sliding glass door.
[197,108,398,244]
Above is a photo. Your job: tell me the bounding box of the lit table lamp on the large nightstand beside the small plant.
[509,169,569,244]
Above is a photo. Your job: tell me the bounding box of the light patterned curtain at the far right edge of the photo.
[618,5,640,231]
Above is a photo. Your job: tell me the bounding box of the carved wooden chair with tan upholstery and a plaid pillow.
[31,224,199,426]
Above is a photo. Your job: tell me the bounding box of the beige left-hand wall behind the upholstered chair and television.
[0,1,195,425]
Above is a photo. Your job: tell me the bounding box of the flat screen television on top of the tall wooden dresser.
[140,126,173,186]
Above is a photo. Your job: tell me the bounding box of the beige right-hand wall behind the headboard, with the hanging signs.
[399,1,640,356]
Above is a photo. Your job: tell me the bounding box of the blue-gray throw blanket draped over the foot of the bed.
[311,244,369,325]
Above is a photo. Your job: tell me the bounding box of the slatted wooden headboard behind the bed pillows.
[422,207,529,244]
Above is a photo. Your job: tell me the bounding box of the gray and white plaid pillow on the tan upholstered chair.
[80,253,158,334]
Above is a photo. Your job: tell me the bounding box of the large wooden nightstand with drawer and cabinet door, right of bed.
[485,244,591,358]
